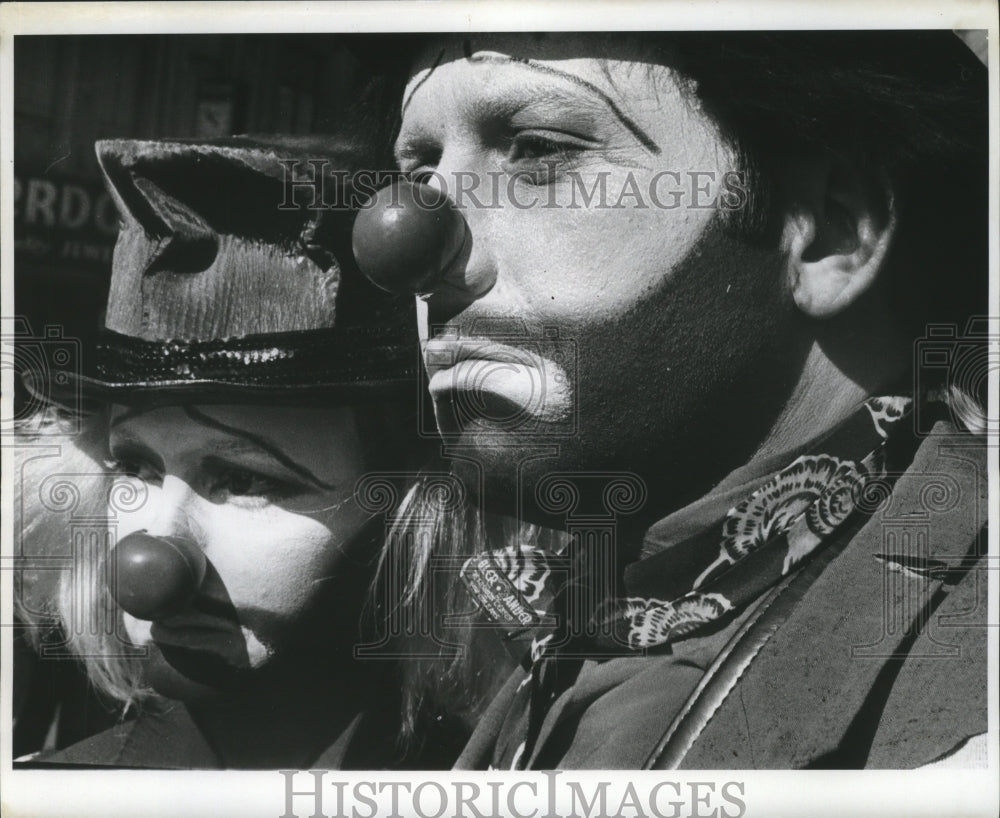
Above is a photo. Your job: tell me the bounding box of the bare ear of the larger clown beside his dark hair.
[782,158,896,318]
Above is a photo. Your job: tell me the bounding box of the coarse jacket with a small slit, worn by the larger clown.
[458,423,987,769]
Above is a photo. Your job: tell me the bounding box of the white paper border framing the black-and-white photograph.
[0,0,1000,818]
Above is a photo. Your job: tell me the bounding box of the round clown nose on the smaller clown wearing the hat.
[109,531,207,621]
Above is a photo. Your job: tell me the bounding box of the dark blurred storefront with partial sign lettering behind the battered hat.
[14,35,367,386]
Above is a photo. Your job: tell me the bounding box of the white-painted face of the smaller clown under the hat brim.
[110,406,367,692]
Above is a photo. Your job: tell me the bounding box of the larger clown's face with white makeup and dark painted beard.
[396,35,787,490]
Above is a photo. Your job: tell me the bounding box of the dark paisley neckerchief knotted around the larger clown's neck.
[461,396,916,769]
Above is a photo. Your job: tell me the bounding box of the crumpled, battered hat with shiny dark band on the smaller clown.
[26,136,418,404]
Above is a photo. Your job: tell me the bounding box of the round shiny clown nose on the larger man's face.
[353,181,465,293]
